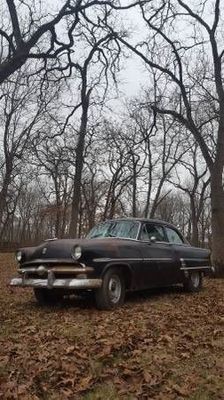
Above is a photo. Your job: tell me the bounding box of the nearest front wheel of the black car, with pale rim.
[95,268,125,310]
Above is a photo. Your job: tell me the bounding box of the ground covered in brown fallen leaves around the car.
[0,254,224,400]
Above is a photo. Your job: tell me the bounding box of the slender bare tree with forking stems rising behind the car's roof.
[128,95,188,218]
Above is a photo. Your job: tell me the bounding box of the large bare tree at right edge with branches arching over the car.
[118,0,224,276]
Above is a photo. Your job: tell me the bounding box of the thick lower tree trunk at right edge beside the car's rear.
[211,166,224,277]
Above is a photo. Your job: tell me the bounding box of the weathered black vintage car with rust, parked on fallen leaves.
[10,218,212,309]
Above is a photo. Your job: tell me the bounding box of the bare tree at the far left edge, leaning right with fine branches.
[0,70,55,237]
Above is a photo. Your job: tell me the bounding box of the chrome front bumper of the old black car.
[10,274,102,289]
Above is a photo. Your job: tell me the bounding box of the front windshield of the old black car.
[87,221,139,239]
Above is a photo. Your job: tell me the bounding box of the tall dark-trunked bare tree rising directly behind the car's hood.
[69,23,120,237]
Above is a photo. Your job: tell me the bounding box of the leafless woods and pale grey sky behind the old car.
[0,0,221,265]
